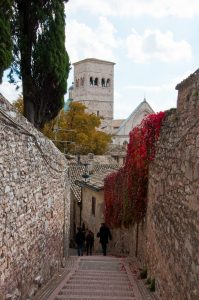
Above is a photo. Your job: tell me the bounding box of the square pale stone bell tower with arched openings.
[72,58,114,133]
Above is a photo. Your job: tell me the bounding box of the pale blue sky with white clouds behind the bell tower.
[0,0,199,118]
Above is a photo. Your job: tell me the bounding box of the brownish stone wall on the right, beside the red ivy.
[146,71,199,300]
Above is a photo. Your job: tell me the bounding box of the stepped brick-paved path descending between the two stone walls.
[48,256,146,300]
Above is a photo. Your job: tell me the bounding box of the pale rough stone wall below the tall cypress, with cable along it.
[0,95,70,299]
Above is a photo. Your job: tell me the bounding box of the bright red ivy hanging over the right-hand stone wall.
[104,112,165,226]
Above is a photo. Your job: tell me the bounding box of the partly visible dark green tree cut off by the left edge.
[0,0,12,83]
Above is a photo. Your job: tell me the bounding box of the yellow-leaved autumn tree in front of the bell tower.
[14,98,111,155]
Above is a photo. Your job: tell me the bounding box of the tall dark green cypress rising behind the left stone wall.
[10,0,70,128]
